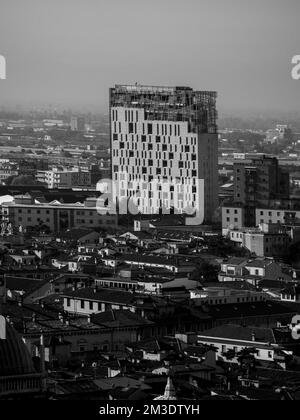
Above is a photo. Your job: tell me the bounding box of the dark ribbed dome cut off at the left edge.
[0,322,35,377]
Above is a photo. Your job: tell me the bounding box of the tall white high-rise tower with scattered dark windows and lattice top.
[110,85,218,225]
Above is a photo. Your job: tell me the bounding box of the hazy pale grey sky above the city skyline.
[0,0,300,111]
